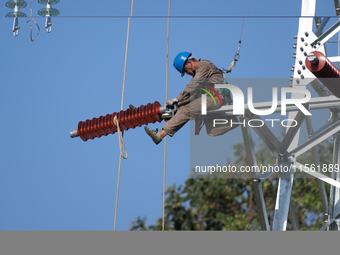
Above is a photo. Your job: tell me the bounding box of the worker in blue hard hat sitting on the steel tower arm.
[144,52,236,144]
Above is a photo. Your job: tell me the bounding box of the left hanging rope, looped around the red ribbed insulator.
[113,0,133,231]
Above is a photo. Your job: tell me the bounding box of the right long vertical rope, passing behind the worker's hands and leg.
[162,0,171,231]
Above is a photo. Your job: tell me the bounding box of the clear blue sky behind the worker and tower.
[0,0,337,230]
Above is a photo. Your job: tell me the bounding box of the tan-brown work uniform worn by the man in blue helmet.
[162,59,234,136]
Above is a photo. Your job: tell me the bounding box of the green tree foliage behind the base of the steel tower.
[130,141,332,230]
